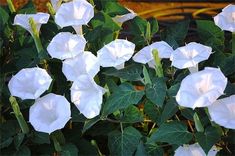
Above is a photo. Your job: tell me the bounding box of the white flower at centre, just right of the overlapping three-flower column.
[97,39,135,69]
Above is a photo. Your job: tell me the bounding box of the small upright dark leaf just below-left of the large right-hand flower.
[161,99,178,123]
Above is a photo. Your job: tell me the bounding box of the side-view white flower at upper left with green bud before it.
[14,12,50,35]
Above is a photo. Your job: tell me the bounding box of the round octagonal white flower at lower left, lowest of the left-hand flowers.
[29,93,71,134]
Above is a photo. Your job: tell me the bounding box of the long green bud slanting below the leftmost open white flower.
[9,96,29,134]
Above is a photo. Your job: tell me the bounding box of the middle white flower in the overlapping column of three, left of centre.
[62,52,100,81]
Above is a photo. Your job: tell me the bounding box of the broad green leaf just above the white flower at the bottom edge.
[149,121,193,145]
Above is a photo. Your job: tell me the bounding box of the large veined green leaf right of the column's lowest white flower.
[102,83,144,117]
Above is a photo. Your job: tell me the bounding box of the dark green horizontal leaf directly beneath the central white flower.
[103,64,142,81]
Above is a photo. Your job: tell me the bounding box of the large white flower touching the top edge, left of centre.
[55,0,94,28]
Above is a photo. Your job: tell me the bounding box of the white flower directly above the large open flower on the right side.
[170,42,212,69]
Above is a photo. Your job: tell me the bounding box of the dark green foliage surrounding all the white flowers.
[0,0,235,156]
